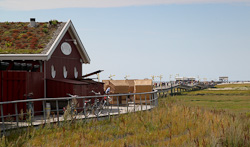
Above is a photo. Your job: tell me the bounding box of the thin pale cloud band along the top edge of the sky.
[0,0,250,10]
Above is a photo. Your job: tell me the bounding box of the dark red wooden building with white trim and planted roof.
[0,19,103,114]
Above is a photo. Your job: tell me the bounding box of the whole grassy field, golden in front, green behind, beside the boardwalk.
[0,85,250,147]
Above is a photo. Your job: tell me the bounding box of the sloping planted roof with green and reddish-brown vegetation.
[0,20,61,54]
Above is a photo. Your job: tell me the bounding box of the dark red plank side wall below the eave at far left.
[0,71,44,115]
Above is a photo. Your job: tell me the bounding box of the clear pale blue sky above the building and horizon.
[0,0,250,80]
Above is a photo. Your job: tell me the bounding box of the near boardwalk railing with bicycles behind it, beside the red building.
[0,90,158,134]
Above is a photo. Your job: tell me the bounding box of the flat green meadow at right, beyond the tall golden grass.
[176,84,250,113]
